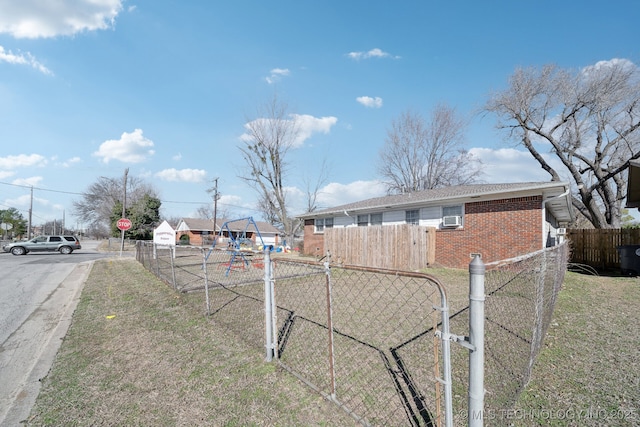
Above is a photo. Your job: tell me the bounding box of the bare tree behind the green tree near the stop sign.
[73,176,158,235]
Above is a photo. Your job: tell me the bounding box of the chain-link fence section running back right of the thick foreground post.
[450,243,569,426]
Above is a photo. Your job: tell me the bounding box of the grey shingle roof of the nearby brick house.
[298,181,568,219]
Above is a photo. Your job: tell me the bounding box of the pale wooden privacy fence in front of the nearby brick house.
[324,224,436,270]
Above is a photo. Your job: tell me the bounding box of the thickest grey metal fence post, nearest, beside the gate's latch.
[468,256,485,427]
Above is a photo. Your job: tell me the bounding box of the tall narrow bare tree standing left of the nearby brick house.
[239,96,300,246]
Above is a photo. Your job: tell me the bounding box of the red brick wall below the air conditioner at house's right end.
[436,196,542,268]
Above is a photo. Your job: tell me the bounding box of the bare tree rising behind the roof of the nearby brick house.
[378,104,481,193]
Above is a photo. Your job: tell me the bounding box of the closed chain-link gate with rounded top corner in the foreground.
[265,251,451,426]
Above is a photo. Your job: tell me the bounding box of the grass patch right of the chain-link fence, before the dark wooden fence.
[512,273,640,426]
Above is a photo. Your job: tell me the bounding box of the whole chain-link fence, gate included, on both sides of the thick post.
[136,242,568,426]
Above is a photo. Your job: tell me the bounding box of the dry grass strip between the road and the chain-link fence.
[26,259,355,426]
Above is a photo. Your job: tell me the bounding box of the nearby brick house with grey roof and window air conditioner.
[299,182,573,268]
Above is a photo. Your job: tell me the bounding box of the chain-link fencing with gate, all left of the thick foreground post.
[137,242,450,426]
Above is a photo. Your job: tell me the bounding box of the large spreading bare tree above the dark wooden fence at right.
[485,60,640,228]
